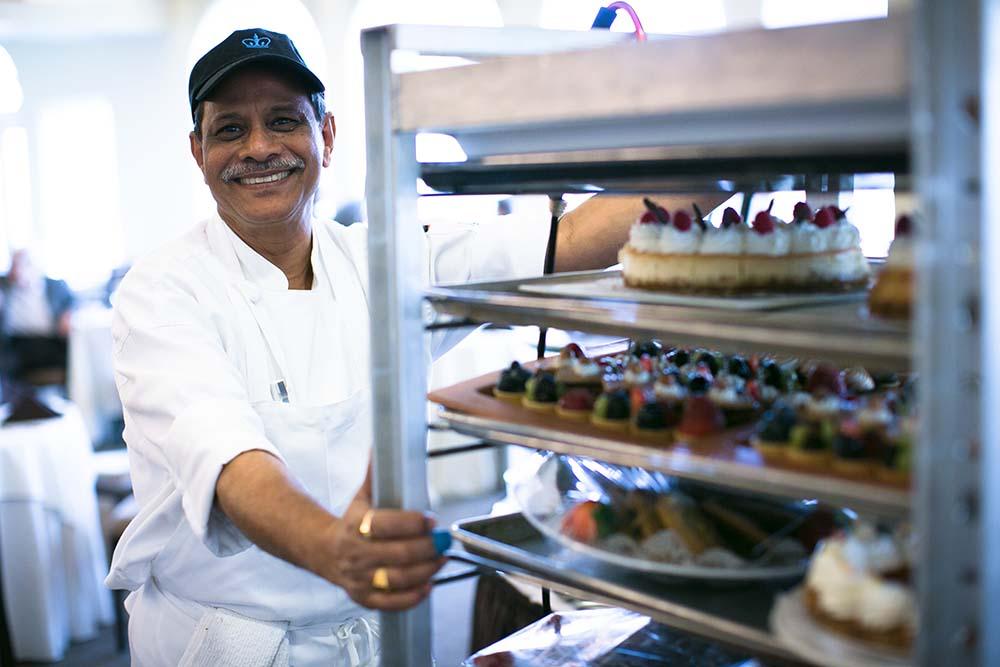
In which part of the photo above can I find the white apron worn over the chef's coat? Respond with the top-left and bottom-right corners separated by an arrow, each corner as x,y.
127,227 -> 378,667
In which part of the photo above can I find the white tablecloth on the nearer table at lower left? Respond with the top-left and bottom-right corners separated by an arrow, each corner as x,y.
0,404 -> 112,661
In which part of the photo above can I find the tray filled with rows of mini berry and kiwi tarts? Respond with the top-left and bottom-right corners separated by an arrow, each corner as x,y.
430,340 -> 917,490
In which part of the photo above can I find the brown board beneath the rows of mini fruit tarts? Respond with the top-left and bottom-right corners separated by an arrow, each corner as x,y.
428,362 -> 909,491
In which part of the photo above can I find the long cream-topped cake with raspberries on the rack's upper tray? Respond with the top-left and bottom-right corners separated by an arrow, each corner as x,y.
618,199 -> 870,294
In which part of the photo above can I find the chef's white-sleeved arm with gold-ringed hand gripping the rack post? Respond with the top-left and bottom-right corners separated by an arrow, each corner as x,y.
112,264 -> 441,609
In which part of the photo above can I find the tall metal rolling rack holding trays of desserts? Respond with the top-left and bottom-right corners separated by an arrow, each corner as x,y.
362,1 -> 1000,666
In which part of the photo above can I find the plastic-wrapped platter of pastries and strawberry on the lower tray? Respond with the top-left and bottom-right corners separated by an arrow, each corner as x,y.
508,454 -> 851,583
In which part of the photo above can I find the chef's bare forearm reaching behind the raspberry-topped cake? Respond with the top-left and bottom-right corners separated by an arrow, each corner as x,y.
555,194 -> 729,271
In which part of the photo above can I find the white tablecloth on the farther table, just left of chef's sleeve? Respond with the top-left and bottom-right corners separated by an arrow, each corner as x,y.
67,305 -> 122,442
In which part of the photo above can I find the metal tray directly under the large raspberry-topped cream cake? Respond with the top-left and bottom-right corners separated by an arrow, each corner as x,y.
426,272 -> 911,372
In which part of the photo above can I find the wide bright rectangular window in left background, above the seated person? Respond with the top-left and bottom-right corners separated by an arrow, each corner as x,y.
38,97 -> 124,289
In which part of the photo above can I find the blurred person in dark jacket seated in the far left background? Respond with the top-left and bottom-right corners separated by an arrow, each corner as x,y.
0,249 -> 76,384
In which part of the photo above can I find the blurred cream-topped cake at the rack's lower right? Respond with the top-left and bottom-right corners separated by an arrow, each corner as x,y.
805,524 -> 917,650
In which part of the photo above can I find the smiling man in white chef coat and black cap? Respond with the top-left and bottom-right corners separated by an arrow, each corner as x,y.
108,29 -> 688,667
